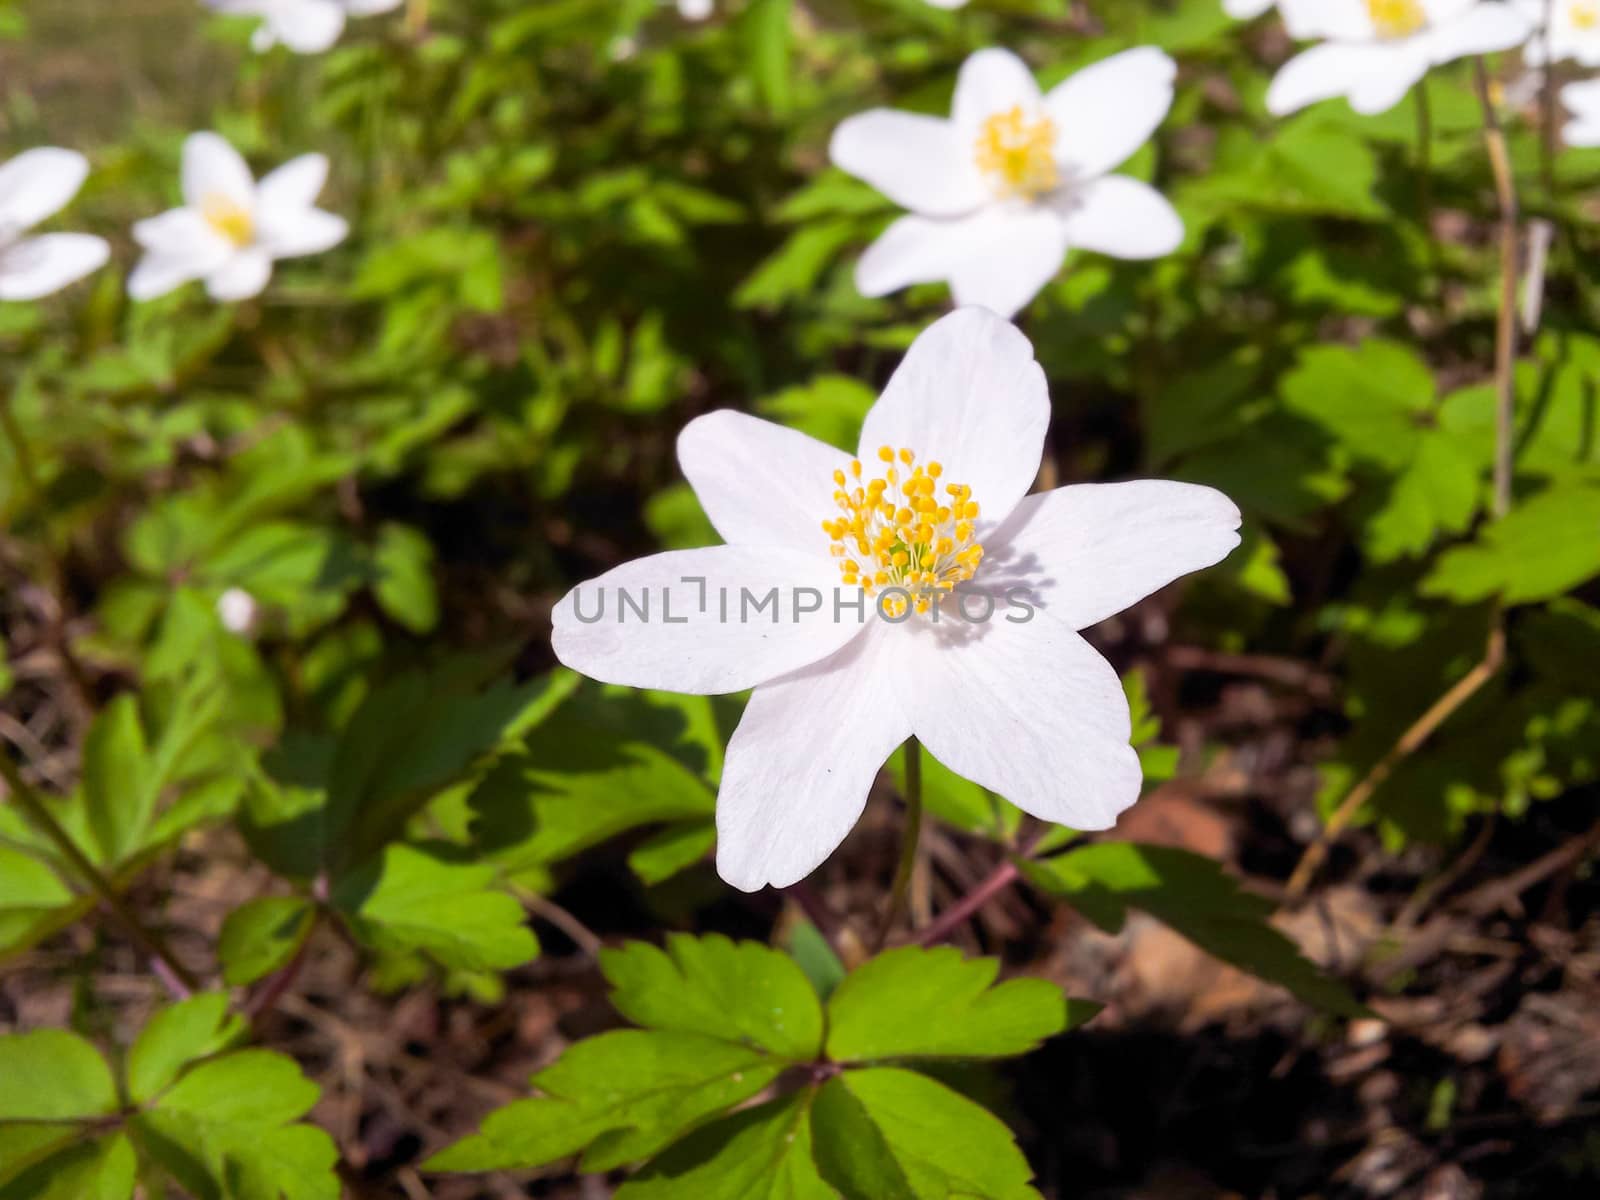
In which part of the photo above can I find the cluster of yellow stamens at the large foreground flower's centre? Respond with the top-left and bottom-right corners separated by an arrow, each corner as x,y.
822,446 -> 984,618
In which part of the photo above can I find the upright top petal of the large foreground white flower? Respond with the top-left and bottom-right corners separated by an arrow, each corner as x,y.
861,309 -> 1050,523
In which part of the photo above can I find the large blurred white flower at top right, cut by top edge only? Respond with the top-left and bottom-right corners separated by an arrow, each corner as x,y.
1267,0 -> 1533,117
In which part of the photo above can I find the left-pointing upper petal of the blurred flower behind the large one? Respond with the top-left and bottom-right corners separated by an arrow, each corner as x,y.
827,109 -> 987,216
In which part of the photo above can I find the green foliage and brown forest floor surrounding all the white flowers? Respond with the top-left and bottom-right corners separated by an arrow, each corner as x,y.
0,0 -> 1600,1200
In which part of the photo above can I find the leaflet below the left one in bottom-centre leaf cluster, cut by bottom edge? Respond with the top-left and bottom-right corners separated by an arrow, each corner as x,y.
616,1091 -> 838,1200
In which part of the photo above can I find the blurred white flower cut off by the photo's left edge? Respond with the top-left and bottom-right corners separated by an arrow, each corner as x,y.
0,146 -> 110,301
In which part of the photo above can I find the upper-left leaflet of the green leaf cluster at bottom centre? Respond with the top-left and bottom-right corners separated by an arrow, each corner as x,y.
600,934 -> 822,1062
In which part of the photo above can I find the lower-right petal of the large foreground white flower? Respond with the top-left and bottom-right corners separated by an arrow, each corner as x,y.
898,610 -> 1142,829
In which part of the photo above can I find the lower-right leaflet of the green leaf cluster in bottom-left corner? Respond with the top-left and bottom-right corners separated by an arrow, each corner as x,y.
133,1050 -> 339,1200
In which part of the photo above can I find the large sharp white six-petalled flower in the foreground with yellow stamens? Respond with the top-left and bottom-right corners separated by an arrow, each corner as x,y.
552,309 -> 1240,891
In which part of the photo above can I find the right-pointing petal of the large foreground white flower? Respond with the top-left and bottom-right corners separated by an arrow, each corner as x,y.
979,480 -> 1240,629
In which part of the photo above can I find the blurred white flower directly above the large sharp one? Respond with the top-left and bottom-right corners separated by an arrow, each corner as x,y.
829,46 -> 1184,317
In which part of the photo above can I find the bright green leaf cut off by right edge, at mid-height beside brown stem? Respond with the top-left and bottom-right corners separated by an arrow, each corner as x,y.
1422,485 -> 1600,605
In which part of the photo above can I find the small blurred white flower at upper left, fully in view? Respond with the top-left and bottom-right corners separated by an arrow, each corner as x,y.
128,133 -> 349,301
